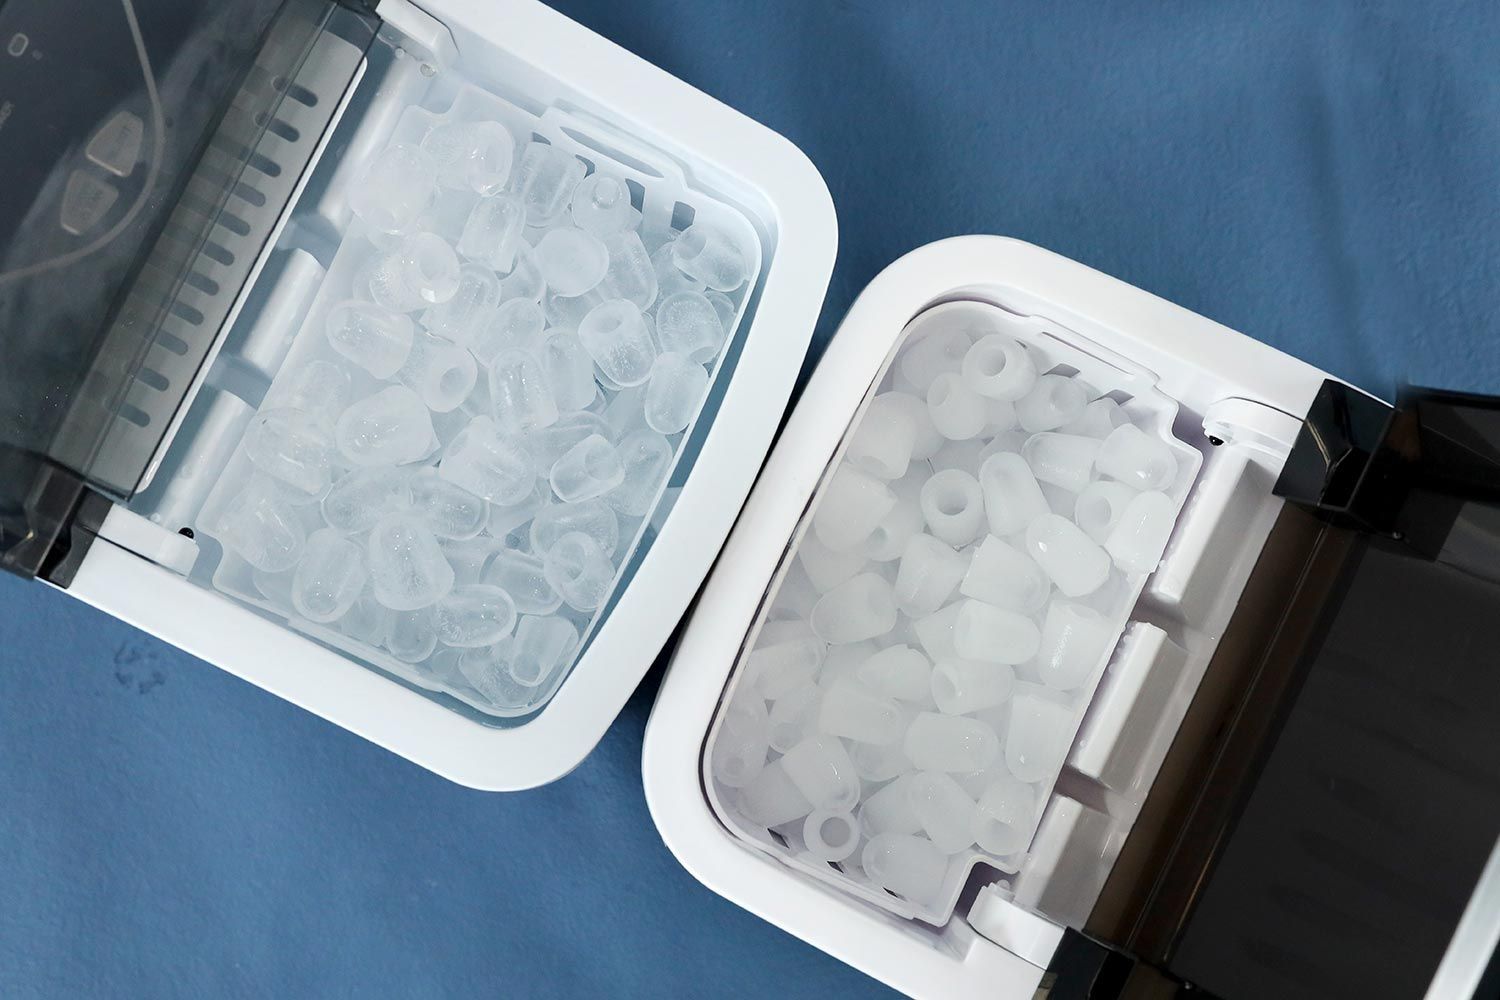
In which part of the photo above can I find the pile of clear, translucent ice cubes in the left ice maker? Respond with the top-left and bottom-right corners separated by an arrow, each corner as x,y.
204,120 -> 752,711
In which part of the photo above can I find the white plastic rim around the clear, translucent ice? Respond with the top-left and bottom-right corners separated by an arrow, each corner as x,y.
68,0 -> 837,790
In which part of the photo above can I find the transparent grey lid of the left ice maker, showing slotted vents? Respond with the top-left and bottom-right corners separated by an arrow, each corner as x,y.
0,0 -> 378,573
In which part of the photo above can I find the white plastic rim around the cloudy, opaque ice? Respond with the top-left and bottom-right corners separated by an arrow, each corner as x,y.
642,235 -> 1325,1000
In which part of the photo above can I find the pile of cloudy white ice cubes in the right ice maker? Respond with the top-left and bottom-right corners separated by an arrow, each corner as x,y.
710,322 -> 1179,913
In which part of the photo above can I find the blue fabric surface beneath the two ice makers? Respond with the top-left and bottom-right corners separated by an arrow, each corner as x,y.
0,0 -> 1500,997
